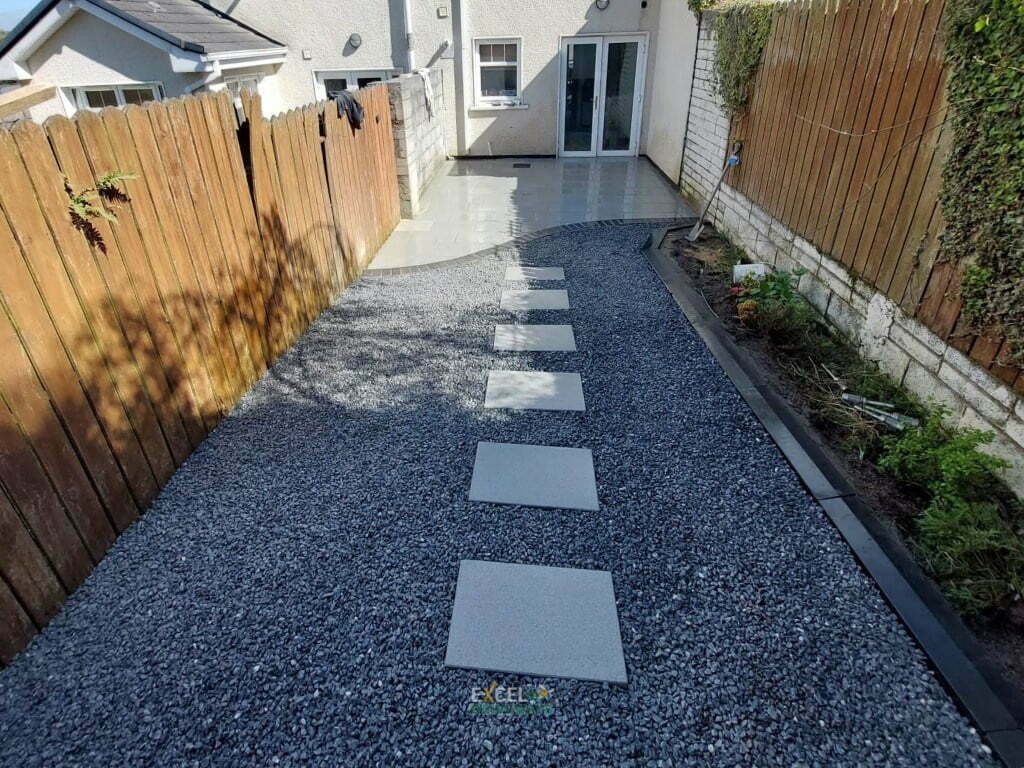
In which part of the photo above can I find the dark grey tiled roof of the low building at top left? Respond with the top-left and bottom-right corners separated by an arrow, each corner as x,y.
0,0 -> 285,55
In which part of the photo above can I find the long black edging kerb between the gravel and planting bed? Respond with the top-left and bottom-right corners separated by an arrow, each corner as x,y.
645,228 -> 1024,768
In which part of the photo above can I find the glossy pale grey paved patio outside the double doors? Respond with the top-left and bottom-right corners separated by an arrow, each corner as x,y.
370,158 -> 695,271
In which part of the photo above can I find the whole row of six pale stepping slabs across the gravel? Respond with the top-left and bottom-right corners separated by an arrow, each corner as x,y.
444,265 -> 627,684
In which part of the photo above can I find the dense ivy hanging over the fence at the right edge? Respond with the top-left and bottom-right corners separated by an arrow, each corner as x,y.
941,0 -> 1024,364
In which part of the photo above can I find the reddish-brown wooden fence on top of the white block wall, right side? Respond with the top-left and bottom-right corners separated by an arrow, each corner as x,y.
730,0 -> 1024,390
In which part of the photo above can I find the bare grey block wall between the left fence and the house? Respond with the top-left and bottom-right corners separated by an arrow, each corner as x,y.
387,69 -> 445,218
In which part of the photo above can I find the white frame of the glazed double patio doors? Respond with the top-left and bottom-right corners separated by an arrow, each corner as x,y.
555,32 -> 650,158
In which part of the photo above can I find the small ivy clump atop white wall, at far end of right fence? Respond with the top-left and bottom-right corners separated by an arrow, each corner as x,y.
714,2 -> 775,118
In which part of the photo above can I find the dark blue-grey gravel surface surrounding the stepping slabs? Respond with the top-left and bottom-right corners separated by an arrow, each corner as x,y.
0,225 -> 990,768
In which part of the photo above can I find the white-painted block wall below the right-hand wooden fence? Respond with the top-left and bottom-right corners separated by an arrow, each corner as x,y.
680,13 -> 1024,496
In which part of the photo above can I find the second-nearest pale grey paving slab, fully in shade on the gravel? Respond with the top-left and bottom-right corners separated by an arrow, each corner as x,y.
469,442 -> 600,511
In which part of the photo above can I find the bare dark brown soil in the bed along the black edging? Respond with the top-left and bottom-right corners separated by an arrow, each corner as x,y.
664,228 -> 1024,700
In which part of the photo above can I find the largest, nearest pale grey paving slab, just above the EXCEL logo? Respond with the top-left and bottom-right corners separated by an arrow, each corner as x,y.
444,560 -> 627,685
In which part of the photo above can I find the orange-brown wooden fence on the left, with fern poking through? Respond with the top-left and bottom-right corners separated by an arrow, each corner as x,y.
0,87 -> 398,660
